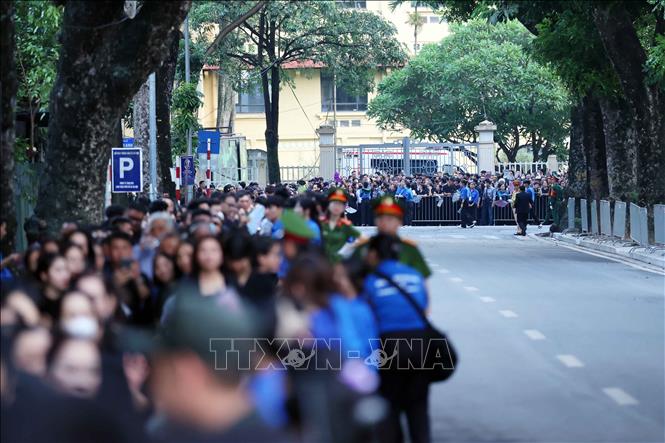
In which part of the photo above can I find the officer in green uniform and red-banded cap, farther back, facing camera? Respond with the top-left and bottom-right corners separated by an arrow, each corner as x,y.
321,189 -> 361,263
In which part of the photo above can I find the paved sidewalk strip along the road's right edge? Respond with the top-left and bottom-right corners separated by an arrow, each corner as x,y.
552,233 -> 665,271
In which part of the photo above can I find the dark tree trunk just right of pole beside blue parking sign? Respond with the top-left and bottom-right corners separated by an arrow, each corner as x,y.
156,35 -> 180,198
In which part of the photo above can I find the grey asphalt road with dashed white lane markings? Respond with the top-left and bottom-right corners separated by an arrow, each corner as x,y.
364,227 -> 665,442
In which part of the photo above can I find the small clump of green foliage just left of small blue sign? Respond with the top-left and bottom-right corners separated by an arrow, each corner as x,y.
171,82 -> 202,155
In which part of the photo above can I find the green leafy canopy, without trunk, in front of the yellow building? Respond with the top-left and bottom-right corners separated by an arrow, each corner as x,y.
184,1 -> 406,96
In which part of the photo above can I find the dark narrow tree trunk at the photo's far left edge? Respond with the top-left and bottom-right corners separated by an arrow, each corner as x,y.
0,1 -> 18,254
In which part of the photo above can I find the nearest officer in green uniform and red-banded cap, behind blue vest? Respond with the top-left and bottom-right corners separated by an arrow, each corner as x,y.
354,195 -> 432,278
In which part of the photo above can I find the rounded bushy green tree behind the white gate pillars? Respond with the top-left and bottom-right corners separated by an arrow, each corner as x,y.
368,20 -> 569,162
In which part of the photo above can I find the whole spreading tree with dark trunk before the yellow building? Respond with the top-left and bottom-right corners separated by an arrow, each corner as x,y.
192,1 -> 405,183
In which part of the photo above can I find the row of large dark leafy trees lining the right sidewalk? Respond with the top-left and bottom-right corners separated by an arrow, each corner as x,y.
402,0 -> 665,204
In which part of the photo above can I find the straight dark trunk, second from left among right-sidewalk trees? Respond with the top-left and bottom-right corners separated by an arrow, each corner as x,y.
583,94 -> 609,199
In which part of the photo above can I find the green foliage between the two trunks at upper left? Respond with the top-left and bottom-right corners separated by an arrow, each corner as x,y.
15,0 -> 62,109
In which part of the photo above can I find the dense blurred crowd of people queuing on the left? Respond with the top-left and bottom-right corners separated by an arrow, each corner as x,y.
0,181 -> 454,442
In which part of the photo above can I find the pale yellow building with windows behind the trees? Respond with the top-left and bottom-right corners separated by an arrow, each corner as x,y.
199,1 -> 448,166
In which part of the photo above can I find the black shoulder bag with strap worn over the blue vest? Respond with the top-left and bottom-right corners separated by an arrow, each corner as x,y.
375,271 -> 457,382
